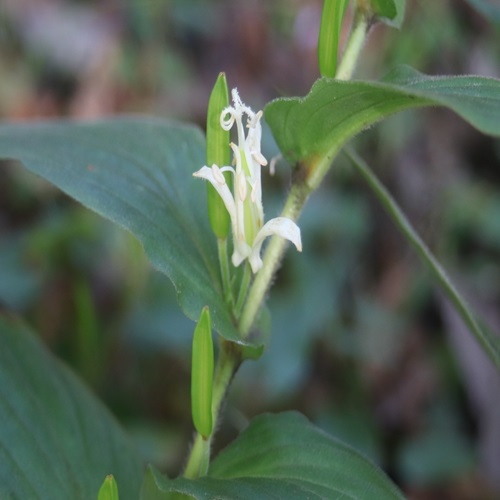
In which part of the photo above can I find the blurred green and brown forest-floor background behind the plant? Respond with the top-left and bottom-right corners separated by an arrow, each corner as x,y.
0,0 -> 500,500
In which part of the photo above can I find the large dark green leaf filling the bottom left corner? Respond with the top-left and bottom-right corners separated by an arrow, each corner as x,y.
0,315 -> 142,500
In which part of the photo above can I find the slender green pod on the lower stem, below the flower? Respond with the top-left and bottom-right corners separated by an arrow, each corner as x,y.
191,307 -> 214,438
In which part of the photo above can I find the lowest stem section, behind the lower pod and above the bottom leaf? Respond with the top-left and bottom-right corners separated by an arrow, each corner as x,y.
184,340 -> 241,479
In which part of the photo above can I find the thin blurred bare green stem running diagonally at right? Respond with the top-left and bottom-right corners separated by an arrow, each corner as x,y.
345,149 -> 500,366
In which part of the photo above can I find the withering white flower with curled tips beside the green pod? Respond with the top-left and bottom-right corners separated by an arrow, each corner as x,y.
193,89 -> 302,273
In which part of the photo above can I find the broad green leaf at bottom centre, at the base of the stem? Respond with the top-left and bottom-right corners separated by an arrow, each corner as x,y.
141,412 -> 403,500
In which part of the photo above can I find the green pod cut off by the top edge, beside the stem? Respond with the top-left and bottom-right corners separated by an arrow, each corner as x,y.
318,0 -> 349,78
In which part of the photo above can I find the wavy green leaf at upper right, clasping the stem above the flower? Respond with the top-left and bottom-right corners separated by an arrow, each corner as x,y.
265,66 -> 500,166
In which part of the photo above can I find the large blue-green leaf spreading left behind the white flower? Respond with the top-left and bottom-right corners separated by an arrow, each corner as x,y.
0,117 -> 243,341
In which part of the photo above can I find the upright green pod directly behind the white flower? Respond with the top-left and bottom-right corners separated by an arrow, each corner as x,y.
207,73 -> 232,240
